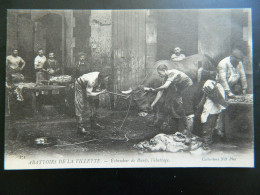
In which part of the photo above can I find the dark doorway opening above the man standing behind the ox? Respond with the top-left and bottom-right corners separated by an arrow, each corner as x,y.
157,10 -> 198,60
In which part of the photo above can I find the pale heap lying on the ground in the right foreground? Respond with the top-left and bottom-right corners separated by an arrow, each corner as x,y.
134,132 -> 202,152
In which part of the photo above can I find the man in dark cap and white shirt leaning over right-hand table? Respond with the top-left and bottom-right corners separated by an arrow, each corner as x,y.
217,49 -> 247,97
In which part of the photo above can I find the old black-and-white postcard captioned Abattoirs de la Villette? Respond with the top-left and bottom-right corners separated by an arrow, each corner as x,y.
4,9 -> 254,170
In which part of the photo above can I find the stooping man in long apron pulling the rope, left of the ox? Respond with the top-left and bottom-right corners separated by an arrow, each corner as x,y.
74,69 -> 110,134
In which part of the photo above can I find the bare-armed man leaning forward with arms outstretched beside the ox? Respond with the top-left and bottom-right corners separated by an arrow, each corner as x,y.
144,64 -> 194,144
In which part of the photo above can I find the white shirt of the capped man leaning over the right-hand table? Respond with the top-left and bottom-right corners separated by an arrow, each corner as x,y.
217,56 -> 247,91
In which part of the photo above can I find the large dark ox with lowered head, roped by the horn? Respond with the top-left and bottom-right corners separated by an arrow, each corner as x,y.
122,54 -> 217,112
